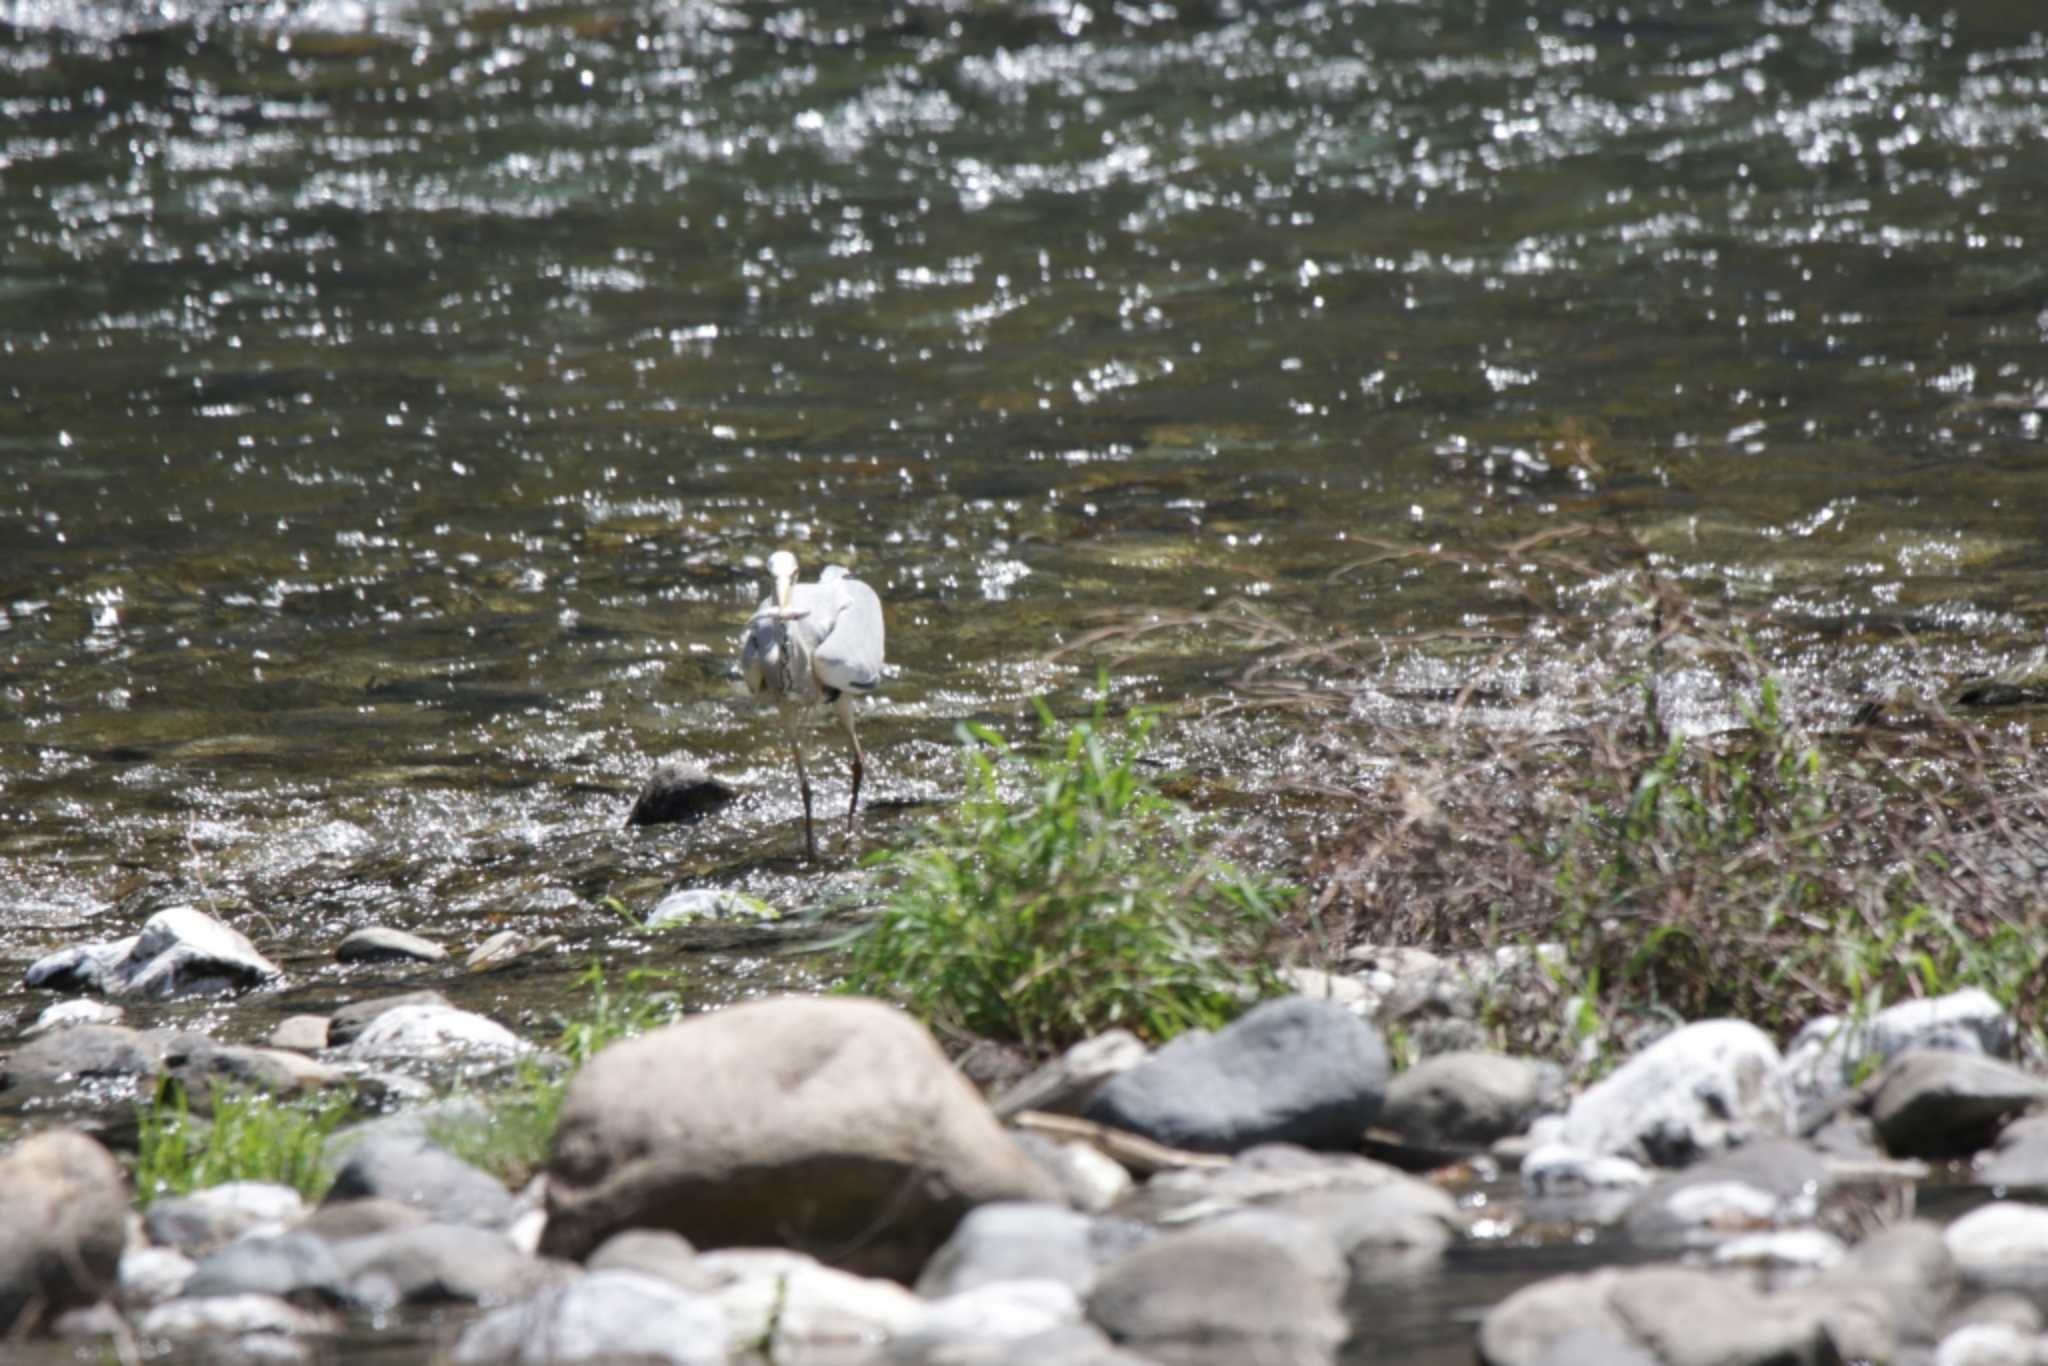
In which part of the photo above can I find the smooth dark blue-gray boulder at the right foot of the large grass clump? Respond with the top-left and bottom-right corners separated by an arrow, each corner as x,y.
1083,995 -> 1386,1153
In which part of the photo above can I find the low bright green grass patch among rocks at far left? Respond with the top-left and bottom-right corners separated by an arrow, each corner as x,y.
135,1077 -> 354,1206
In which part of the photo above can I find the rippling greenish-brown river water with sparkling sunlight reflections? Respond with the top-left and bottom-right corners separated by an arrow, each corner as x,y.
0,0 -> 2048,1359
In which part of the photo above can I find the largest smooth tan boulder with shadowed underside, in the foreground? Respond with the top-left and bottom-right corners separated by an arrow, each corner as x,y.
543,997 -> 1061,1280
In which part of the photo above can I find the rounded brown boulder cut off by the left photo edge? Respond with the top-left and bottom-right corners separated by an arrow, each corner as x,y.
0,1130 -> 127,1341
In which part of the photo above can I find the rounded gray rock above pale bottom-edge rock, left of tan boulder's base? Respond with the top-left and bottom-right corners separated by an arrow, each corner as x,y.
334,1223 -> 565,1311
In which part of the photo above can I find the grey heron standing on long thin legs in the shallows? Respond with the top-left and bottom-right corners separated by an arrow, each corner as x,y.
739,551 -> 883,858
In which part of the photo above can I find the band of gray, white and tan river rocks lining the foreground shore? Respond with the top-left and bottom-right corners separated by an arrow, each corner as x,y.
0,909 -> 2048,1366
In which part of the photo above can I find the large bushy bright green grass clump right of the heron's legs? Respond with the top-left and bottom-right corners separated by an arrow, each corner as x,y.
842,702 -> 1292,1049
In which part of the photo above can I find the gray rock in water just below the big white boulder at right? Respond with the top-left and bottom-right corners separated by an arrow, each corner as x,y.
1626,1139 -> 1831,1249
